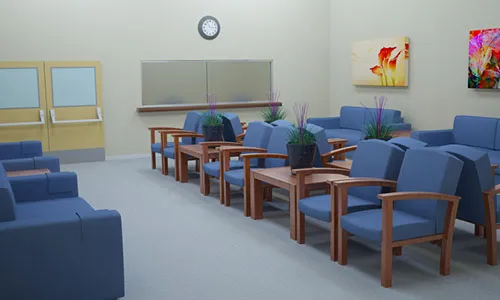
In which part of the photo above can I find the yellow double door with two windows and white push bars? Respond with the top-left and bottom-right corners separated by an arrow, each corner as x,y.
0,62 -> 104,161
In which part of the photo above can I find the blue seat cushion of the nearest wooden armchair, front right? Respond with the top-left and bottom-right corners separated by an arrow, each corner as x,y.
340,209 -> 437,241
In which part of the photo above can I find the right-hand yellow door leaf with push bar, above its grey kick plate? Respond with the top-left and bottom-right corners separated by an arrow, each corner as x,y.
45,62 -> 104,151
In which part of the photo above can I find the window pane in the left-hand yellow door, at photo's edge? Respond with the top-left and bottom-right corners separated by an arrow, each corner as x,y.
0,68 -> 40,109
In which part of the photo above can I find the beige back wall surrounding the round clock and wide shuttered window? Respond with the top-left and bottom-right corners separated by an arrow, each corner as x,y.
0,0 -> 330,155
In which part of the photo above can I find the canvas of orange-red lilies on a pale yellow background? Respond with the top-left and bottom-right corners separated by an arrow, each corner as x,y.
351,37 -> 410,87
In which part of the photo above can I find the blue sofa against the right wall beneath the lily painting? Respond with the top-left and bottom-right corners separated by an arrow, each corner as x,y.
307,106 -> 411,146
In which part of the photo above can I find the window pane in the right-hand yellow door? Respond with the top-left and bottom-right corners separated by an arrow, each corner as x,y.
51,67 -> 97,107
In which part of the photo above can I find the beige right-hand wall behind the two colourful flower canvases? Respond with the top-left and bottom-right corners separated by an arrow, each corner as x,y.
330,0 -> 500,129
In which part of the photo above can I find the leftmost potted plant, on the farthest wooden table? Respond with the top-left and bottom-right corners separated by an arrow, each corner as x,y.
202,94 -> 224,142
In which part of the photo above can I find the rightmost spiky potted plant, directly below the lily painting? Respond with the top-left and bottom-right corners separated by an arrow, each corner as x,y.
364,96 -> 393,141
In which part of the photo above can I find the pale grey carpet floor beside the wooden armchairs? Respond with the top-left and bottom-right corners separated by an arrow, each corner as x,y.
64,159 -> 500,300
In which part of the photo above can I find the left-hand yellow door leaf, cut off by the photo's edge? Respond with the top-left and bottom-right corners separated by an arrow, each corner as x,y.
0,62 -> 49,151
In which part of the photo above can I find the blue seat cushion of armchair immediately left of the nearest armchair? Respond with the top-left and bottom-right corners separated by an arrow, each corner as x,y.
299,195 -> 380,222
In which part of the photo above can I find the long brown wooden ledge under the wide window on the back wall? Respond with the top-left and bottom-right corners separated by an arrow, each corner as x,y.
137,101 -> 283,113
